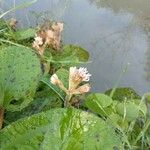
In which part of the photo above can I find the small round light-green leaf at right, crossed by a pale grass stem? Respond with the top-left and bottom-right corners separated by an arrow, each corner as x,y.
116,101 -> 139,121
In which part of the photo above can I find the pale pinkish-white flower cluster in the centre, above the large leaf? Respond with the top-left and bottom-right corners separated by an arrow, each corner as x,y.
50,67 -> 91,106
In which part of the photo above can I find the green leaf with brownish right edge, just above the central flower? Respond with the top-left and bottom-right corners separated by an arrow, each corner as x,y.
53,45 -> 89,66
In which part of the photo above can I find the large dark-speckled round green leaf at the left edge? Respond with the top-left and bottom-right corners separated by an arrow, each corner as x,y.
0,46 -> 41,111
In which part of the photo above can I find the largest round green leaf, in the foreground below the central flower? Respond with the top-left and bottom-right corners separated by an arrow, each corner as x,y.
0,108 -> 123,150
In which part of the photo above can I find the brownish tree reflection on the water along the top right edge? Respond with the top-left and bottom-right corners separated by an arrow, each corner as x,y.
88,0 -> 150,80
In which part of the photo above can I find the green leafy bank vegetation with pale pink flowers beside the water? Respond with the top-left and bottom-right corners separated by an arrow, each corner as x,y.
0,15 -> 150,150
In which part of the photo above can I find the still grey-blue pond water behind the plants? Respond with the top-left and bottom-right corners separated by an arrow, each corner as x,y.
0,0 -> 150,94
